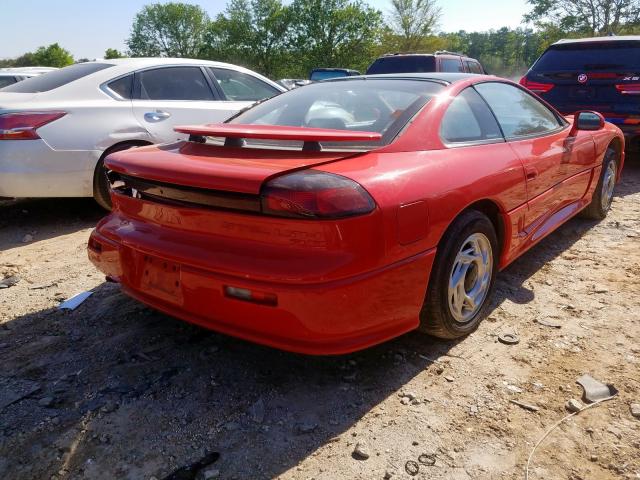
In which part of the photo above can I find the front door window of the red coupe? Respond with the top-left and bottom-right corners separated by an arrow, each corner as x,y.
475,82 -> 561,138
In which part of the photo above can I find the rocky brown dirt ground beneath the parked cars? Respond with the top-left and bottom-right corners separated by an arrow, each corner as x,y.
0,161 -> 640,480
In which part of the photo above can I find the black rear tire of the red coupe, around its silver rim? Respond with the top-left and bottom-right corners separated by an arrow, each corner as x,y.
419,210 -> 500,339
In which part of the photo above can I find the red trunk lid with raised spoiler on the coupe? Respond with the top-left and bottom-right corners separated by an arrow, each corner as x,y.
105,124 -> 379,195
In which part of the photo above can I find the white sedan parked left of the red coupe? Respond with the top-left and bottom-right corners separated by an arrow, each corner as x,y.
0,58 -> 285,208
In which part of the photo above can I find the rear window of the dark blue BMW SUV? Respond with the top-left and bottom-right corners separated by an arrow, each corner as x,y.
532,42 -> 640,73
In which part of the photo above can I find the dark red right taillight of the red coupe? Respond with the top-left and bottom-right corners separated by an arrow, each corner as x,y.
262,170 -> 376,219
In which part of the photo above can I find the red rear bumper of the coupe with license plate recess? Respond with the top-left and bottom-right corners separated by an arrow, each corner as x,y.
89,228 -> 435,355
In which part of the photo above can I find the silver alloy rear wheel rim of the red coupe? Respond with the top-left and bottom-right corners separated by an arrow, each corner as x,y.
449,233 -> 493,323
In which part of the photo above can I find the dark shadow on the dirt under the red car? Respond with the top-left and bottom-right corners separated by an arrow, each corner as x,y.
0,283 -> 456,479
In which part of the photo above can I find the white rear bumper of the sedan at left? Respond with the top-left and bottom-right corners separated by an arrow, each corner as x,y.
0,140 -> 101,197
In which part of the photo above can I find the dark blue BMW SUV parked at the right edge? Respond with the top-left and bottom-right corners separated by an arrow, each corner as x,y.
520,36 -> 640,151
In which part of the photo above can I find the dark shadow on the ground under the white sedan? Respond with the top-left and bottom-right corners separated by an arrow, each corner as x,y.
0,198 -> 106,251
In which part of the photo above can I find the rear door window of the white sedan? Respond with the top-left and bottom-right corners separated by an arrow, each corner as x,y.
136,67 -> 214,100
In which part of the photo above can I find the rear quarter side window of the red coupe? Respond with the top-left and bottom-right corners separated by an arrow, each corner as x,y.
440,87 -> 503,143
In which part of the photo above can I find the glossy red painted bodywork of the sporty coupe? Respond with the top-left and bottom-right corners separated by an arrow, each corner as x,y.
89,76 -> 624,354
